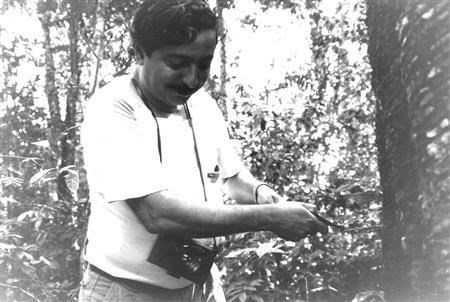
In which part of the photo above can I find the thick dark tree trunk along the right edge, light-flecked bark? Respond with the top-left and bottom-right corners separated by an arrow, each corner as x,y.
367,0 -> 450,301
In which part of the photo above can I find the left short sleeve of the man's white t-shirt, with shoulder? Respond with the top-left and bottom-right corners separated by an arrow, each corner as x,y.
81,96 -> 167,202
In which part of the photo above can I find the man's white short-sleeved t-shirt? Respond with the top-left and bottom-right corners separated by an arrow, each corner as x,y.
81,75 -> 242,289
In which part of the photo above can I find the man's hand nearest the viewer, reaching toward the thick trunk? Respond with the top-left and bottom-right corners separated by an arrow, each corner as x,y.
271,202 -> 328,241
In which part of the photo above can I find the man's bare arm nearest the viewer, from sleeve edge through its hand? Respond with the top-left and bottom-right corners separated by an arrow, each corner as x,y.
128,191 -> 328,241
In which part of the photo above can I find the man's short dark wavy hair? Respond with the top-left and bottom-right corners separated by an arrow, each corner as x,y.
131,0 -> 218,56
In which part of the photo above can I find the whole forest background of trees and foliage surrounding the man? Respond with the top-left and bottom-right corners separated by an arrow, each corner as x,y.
0,0 -> 450,301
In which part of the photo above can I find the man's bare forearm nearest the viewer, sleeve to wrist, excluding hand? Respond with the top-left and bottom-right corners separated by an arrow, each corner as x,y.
128,191 -> 276,238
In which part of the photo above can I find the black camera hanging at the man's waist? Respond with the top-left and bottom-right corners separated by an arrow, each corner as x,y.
147,234 -> 217,285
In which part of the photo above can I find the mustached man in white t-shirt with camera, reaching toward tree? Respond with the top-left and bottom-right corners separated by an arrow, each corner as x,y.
79,0 -> 327,301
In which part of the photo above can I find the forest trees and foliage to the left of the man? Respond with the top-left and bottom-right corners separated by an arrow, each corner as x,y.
0,0 -> 144,301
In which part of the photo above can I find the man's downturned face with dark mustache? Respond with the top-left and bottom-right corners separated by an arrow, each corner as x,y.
137,30 -> 216,109
